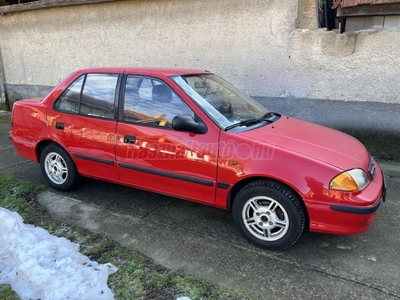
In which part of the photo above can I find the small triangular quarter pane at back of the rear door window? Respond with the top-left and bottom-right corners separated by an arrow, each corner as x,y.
54,76 -> 85,113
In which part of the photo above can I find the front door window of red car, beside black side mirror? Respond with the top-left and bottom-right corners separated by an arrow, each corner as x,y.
123,75 -> 194,128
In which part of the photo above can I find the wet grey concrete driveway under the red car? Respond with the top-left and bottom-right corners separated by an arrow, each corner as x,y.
0,123 -> 400,299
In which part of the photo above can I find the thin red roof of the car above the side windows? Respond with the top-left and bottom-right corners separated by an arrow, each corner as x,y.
77,67 -> 210,76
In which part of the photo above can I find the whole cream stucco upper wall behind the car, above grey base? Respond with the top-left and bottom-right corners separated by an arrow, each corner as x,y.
0,0 -> 400,103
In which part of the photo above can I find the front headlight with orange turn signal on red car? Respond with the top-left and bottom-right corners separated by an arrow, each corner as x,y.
329,169 -> 369,192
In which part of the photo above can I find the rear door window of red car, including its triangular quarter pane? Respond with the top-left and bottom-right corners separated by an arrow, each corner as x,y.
54,74 -> 119,119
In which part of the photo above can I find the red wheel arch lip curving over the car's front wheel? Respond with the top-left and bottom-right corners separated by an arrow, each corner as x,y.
227,176 -> 310,231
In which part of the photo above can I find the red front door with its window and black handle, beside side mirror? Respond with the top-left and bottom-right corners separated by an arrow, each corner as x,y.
116,75 -> 218,202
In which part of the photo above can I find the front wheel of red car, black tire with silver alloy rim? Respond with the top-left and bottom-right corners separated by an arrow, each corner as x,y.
232,180 -> 306,250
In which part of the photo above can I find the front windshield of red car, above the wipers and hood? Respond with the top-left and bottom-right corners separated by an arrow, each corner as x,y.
172,74 -> 268,128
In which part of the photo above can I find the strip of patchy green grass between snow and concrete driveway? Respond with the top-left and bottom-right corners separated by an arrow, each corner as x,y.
0,174 -> 255,300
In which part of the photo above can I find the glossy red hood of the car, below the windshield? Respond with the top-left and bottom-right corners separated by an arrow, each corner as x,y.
240,115 -> 369,170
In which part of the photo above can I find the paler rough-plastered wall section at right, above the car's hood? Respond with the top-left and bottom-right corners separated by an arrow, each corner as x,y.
288,29 -> 400,103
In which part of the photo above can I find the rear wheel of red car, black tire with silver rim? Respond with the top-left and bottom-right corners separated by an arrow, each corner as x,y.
40,145 -> 80,191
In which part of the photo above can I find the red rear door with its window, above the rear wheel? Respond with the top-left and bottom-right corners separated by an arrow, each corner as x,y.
48,74 -> 121,180
